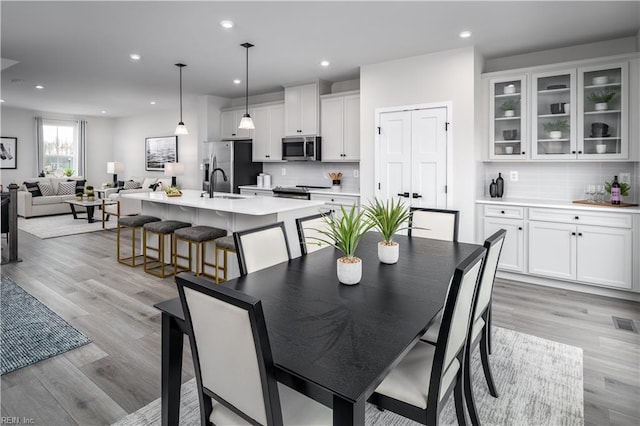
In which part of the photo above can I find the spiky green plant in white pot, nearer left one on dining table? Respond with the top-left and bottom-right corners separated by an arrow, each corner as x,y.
309,206 -> 373,285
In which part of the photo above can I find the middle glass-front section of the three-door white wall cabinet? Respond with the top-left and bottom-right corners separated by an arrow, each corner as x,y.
531,70 -> 577,159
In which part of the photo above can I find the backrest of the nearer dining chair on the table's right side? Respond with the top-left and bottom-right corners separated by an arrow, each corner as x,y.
429,248 -> 486,395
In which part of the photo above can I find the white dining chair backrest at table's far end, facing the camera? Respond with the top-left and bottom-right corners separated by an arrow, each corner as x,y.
409,207 -> 460,241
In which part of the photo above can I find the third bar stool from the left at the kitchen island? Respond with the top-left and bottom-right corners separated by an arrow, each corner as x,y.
173,225 -> 227,279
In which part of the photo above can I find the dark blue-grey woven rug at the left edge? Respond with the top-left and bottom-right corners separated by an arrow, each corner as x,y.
0,277 -> 91,375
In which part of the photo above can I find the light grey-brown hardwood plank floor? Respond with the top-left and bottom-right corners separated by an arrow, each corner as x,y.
0,231 -> 640,425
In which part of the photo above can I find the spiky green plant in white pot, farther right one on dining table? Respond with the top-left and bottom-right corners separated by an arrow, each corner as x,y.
364,198 -> 411,264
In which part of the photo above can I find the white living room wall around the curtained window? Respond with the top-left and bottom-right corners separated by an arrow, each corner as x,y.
1,106 -> 113,186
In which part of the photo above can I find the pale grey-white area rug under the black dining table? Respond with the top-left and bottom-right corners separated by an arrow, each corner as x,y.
114,327 -> 584,426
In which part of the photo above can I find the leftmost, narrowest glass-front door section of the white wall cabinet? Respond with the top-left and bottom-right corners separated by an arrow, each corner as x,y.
489,76 -> 527,161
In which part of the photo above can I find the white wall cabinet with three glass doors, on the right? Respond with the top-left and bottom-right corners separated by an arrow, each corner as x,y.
488,55 -> 640,161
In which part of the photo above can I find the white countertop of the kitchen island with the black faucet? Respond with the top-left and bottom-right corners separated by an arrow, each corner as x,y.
122,189 -> 324,216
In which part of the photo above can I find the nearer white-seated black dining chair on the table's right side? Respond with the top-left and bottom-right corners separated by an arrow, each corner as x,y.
369,248 -> 485,425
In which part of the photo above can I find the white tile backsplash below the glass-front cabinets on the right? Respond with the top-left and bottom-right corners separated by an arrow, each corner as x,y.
479,162 -> 640,202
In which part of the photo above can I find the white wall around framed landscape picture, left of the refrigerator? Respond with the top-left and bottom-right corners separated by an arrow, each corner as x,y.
111,96 -> 201,189
